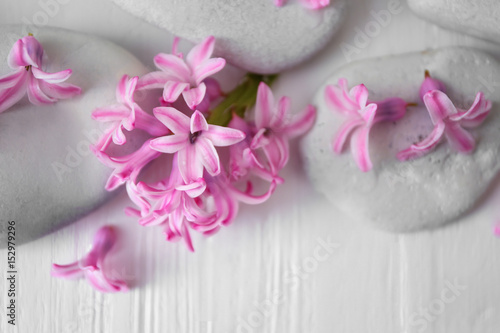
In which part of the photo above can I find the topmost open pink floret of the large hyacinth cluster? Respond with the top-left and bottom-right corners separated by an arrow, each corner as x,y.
138,36 -> 226,110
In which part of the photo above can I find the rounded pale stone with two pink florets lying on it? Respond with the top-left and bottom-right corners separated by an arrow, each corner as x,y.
301,48 -> 500,232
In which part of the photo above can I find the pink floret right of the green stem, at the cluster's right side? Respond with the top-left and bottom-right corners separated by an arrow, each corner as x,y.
250,82 -> 316,175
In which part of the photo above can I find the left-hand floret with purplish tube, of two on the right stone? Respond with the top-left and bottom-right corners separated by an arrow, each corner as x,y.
325,78 -> 407,172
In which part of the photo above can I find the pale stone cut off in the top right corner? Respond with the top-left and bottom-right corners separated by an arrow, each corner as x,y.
408,0 -> 500,43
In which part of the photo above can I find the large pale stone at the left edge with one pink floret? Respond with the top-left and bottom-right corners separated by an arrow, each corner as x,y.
0,26 -> 147,247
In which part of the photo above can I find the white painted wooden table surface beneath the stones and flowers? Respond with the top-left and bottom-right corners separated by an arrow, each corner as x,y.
0,0 -> 500,333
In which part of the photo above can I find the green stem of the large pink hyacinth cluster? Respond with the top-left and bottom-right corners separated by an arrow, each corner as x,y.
207,73 -> 278,126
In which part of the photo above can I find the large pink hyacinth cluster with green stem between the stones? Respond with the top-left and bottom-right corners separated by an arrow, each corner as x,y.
87,37 -> 316,251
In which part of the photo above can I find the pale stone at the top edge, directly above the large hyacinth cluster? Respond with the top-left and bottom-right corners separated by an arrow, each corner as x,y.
107,0 -> 345,74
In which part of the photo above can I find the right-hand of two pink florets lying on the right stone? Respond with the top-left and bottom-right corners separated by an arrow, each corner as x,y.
397,90 -> 491,161
